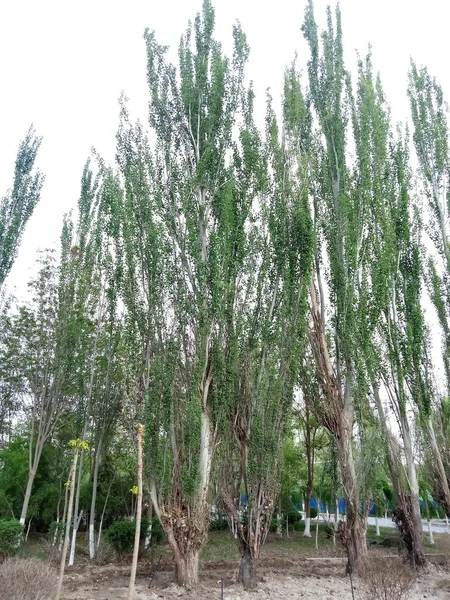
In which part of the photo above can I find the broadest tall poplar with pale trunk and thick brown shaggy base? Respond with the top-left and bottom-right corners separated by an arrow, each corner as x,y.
116,0 -> 255,586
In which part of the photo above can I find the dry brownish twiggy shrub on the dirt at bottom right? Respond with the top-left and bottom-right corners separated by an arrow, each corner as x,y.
359,557 -> 416,600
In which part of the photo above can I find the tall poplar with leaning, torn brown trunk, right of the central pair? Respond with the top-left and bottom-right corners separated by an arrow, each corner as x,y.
303,0 -> 367,570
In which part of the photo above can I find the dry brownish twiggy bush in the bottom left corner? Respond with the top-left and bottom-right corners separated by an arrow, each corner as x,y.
0,557 -> 57,600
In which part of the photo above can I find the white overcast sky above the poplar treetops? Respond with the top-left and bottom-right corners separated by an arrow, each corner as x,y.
0,0 -> 450,294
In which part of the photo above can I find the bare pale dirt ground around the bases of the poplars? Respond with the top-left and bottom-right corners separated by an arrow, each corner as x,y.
63,556 -> 450,600
